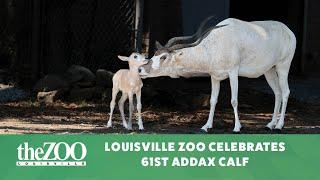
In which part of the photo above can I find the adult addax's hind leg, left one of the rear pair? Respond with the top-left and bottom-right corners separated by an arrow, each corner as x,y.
264,68 -> 281,129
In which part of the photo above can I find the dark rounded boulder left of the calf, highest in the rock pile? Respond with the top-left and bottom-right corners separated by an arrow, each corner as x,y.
64,65 -> 96,87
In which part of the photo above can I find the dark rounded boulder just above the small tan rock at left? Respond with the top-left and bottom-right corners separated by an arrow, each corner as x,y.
33,74 -> 70,92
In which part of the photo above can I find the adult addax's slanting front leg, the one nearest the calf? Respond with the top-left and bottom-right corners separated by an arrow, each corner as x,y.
201,77 -> 220,132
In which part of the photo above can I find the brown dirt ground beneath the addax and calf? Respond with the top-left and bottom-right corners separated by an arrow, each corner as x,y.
0,79 -> 320,134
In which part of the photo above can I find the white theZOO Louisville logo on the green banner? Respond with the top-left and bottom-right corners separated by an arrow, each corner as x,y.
16,142 -> 87,166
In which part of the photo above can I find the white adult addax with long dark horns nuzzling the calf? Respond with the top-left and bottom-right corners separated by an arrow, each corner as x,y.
142,18 -> 296,132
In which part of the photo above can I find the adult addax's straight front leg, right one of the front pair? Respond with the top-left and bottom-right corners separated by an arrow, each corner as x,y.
229,69 -> 241,133
